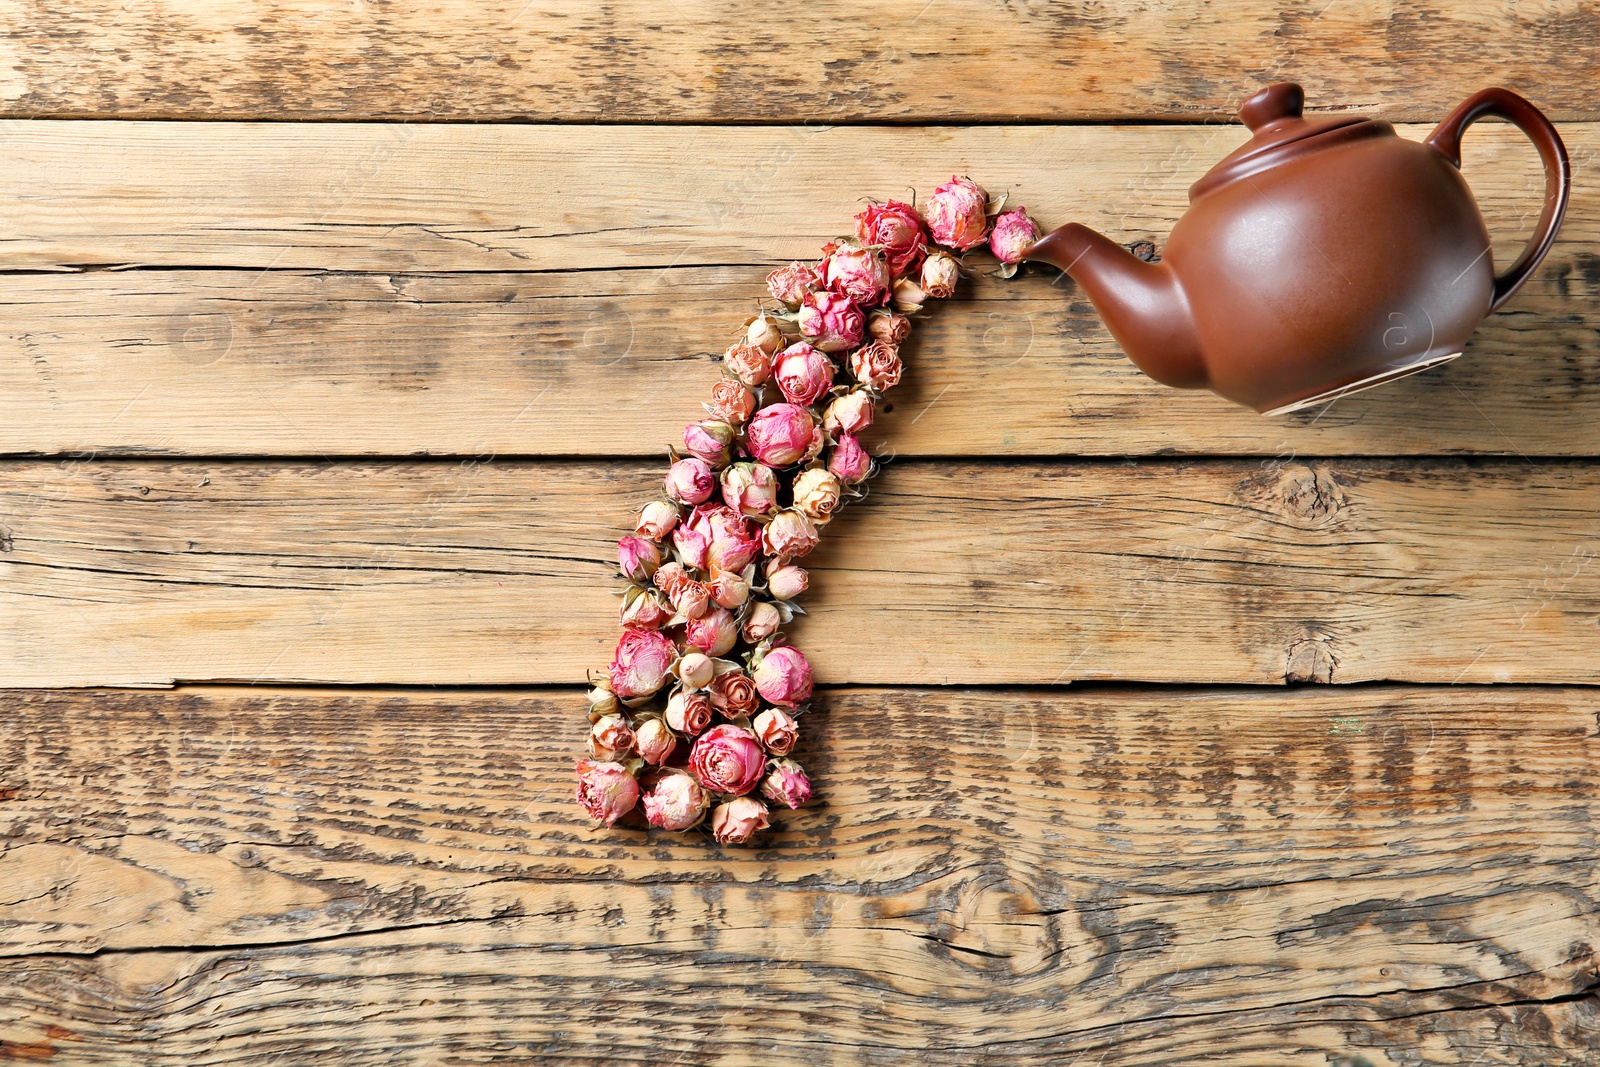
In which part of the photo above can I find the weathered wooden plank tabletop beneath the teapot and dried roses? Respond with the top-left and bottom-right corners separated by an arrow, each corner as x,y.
0,0 -> 1600,1067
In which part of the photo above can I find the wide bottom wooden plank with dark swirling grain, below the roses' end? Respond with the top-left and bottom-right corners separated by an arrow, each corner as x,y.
0,686 -> 1600,1067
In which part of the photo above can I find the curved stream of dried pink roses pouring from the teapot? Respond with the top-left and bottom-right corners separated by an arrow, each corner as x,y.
578,178 -> 1040,843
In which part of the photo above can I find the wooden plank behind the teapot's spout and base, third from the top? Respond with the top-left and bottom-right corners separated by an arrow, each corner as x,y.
0,255 -> 1600,456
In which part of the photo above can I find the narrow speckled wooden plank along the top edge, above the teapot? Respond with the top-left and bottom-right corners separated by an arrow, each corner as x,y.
0,0 -> 1600,123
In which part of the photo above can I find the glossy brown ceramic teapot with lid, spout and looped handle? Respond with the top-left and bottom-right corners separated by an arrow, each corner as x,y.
1024,83 -> 1571,414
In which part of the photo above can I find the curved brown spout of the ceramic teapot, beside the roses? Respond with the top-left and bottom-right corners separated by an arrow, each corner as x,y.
1022,222 -> 1206,389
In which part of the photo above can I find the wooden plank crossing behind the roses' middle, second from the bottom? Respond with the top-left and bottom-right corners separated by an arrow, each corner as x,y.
0,459 -> 1600,686
